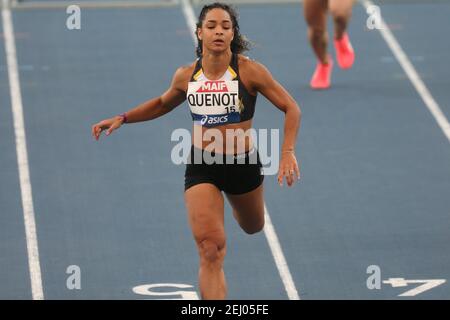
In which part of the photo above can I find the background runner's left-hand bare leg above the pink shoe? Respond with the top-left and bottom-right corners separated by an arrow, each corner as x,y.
303,0 -> 328,64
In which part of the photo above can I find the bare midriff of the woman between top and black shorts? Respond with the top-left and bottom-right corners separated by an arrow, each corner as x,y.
192,119 -> 253,154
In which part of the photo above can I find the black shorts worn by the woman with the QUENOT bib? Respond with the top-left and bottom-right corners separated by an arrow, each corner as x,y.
184,146 -> 264,194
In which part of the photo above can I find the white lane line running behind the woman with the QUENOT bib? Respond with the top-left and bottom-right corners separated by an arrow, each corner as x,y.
180,0 -> 300,300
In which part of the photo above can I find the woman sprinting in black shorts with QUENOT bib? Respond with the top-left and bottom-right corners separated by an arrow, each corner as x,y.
92,3 -> 301,299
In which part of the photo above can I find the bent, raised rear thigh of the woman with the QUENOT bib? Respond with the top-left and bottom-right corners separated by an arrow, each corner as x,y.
226,184 -> 264,234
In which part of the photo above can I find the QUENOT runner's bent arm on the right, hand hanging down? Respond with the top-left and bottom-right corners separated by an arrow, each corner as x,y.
244,61 -> 302,186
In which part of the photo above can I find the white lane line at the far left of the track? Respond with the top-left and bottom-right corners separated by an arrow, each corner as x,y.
2,0 -> 44,300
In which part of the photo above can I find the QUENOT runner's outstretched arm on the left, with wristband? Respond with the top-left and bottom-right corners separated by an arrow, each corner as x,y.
92,67 -> 190,140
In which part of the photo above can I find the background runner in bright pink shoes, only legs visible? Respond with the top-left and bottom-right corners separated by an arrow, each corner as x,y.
303,0 -> 355,89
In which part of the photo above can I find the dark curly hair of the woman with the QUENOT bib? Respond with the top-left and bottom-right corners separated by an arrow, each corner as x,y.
195,2 -> 251,57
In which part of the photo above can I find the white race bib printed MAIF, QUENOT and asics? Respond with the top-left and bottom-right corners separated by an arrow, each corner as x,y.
187,80 -> 241,127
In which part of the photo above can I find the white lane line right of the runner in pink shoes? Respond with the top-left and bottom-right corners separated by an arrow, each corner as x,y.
360,0 -> 450,142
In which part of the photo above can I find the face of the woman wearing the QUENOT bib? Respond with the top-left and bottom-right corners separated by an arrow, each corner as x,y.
197,8 -> 234,53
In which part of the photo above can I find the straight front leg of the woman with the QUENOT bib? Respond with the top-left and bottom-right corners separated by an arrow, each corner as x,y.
184,183 -> 227,299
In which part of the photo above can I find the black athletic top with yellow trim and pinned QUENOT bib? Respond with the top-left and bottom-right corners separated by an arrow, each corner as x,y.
186,53 -> 256,127
